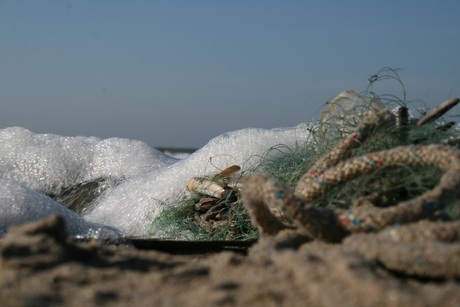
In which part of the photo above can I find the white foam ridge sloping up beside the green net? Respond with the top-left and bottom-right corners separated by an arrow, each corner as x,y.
86,125 -> 309,235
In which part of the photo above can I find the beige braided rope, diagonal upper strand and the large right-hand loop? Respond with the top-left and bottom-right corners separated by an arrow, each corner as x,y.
294,110 -> 460,232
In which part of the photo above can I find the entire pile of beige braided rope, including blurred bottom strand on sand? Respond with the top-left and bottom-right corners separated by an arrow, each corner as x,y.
242,98 -> 460,278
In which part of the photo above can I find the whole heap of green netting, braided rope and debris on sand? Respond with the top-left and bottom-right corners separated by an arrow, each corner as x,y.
147,76 -> 460,280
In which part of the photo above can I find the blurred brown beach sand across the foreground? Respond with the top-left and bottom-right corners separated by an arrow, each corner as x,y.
0,216 -> 460,307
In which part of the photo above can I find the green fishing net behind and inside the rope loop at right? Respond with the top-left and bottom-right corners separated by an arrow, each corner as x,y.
258,91 -> 460,216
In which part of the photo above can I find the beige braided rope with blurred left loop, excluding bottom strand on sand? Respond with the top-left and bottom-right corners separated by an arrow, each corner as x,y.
242,110 -> 460,242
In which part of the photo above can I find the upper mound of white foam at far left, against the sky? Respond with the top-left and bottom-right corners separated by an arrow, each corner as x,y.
0,127 -> 177,193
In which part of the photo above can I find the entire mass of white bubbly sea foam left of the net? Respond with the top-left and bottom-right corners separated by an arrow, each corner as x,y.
0,125 -> 309,236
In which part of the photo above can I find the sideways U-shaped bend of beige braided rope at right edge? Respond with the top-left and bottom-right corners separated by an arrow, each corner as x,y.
332,145 -> 460,232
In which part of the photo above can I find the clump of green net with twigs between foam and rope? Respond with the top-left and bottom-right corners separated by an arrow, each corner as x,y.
149,165 -> 258,240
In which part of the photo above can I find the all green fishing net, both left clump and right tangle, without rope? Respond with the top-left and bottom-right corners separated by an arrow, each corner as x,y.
148,68 -> 460,240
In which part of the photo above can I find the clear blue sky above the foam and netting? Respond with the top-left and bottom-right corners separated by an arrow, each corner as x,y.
0,0 -> 460,147
